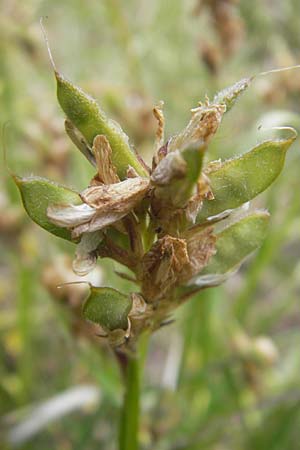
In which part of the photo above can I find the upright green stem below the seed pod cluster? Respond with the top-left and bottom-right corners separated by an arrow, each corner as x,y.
119,355 -> 140,450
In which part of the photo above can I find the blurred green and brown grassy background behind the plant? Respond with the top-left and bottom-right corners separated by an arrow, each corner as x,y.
0,0 -> 300,450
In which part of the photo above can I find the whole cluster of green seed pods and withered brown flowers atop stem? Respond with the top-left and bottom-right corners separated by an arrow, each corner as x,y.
14,54 -> 295,351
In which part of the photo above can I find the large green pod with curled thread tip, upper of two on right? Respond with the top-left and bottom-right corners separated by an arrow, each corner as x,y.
197,136 -> 295,223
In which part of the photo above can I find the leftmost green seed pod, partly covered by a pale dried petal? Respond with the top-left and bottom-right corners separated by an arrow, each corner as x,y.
13,175 -> 82,241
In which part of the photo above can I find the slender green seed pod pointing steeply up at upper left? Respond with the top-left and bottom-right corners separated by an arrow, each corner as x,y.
55,71 -> 148,179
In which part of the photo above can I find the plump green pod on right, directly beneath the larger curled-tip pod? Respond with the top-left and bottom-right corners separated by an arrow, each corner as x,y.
199,211 -> 270,277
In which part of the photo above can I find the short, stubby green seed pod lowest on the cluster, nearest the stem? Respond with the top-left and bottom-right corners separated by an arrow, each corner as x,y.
82,286 -> 132,331
